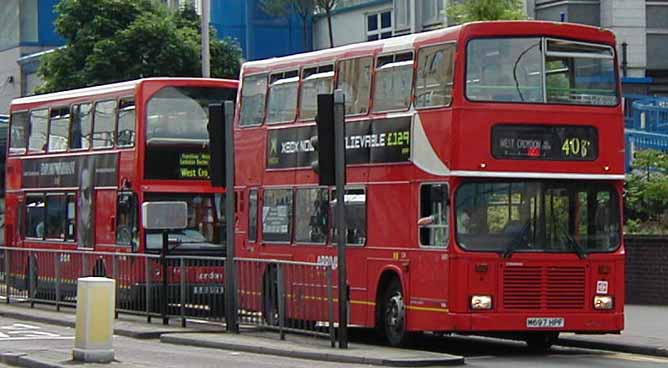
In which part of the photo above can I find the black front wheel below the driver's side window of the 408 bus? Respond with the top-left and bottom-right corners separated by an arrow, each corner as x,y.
380,279 -> 413,346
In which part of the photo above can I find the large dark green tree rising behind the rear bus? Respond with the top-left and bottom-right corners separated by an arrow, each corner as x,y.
37,0 -> 241,93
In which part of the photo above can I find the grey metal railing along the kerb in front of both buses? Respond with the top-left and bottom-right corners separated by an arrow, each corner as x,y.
0,247 -> 337,344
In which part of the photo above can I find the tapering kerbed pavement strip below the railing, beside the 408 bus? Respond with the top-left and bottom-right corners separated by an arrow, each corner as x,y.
160,332 -> 464,367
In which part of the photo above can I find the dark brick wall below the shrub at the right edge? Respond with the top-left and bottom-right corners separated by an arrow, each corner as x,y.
624,236 -> 668,305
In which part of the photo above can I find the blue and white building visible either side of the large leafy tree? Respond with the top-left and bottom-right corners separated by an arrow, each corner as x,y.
0,0 -> 312,114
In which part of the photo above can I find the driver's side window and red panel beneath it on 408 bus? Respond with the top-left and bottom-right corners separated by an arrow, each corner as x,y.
408,183 -> 450,329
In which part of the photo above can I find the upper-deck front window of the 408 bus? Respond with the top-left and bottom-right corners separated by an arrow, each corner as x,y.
466,37 -> 618,106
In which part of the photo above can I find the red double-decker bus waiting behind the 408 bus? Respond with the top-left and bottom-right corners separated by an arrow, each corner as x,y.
5,78 -> 238,310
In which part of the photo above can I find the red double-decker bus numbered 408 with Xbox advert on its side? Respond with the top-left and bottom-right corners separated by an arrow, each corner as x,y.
235,21 -> 624,348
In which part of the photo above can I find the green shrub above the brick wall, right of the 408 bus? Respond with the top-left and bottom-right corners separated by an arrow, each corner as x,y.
626,150 -> 668,233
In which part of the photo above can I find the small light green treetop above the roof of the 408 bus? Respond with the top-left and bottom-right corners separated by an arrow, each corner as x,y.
448,0 -> 527,24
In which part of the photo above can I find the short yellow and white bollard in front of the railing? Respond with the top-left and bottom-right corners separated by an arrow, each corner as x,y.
72,277 -> 116,363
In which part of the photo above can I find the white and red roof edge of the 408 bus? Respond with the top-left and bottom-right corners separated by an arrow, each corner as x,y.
242,20 -> 615,74
